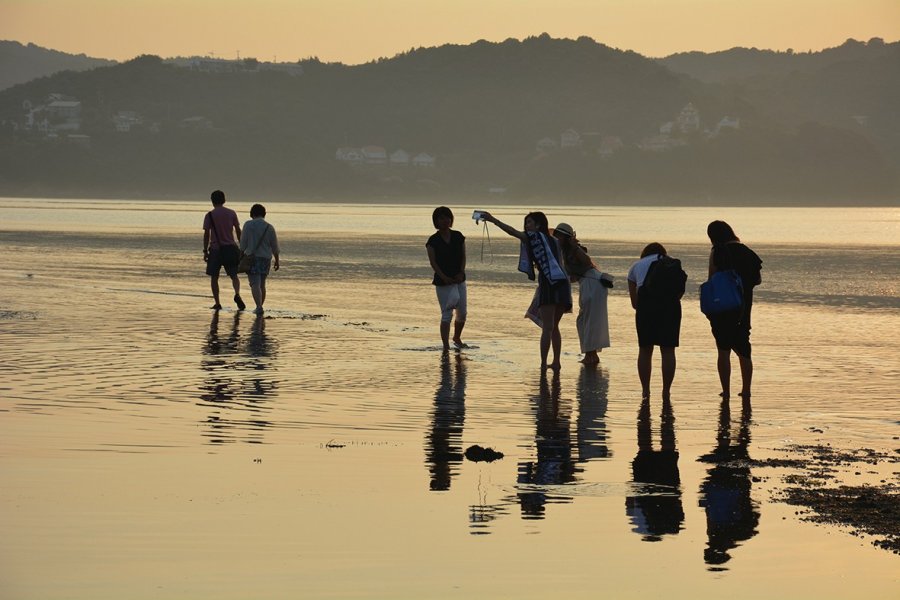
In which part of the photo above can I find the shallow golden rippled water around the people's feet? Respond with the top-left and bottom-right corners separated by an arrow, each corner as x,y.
0,200 -> 900,598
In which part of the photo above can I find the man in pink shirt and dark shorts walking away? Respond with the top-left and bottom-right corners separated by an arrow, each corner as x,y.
203,190 -> 246,310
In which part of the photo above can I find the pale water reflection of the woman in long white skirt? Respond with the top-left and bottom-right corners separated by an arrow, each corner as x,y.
575,365 -> 612,462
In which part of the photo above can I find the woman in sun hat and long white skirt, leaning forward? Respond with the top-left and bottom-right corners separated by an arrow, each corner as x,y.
553,223 -> 612,365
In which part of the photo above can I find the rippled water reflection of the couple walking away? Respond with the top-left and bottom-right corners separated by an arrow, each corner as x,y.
198,311 -> 278,444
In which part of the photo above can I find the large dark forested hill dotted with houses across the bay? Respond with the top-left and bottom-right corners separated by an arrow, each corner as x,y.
0,34 -> 900,203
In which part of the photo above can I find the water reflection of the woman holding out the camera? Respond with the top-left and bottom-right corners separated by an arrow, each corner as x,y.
517,371 -> 575,519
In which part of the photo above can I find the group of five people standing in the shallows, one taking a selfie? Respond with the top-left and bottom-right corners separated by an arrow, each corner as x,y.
426,206 -> 762,401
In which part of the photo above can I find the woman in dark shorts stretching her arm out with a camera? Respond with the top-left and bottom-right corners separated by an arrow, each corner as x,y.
480,211 -> 572,371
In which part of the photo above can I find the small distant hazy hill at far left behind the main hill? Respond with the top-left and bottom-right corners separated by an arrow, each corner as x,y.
0,40 -> 115,90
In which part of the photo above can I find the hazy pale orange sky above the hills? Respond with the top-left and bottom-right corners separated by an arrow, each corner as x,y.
0,0 -> 900,63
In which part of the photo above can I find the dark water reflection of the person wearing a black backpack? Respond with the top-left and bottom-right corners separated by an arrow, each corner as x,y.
625,398 -> 684,542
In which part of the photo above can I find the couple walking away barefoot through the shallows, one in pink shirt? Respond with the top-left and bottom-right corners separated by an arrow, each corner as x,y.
203,190 -> 281,315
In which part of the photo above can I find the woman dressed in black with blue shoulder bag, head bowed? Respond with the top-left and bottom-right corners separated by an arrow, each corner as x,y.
701,221 -> 762,401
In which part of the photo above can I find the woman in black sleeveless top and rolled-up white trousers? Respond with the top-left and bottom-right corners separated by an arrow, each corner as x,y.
425,206 -> 468,352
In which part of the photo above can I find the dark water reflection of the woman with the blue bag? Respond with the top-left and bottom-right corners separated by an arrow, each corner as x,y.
699,400 -> 759,570
